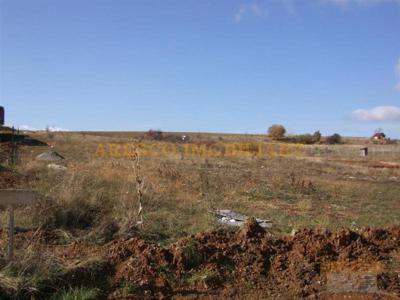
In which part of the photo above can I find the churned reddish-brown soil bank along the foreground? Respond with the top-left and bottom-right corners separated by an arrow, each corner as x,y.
0,220 -> 400,299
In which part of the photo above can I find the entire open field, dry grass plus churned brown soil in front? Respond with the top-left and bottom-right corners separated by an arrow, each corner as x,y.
0,132 -> 400,299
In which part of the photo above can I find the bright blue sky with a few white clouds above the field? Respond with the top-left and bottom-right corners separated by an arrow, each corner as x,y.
0,0 -> 400,138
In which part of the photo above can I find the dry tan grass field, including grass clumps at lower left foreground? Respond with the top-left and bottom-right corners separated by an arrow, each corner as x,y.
0,132 -> 400,299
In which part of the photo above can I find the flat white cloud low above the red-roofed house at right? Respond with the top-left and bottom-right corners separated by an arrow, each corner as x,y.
352,106 -> 400,122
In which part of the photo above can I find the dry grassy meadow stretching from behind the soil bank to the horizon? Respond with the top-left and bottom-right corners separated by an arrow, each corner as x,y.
8,132 -> 400,242
